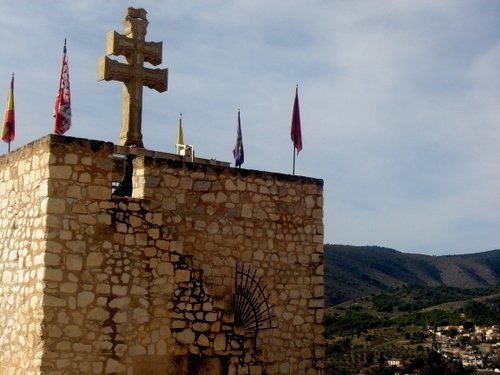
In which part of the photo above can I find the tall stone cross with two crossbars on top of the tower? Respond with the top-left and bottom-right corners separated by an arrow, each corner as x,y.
97,8 -> 168,147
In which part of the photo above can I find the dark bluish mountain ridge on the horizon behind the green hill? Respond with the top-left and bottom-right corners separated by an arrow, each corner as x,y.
324,244 -> 500,307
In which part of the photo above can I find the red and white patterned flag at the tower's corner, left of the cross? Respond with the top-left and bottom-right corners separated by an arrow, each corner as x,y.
54,39 -> 71,134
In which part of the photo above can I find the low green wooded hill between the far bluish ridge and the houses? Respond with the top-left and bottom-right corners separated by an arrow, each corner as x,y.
325,286 -> 500,337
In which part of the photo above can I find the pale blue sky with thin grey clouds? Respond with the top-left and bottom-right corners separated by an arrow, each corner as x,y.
0,0 -> 500,255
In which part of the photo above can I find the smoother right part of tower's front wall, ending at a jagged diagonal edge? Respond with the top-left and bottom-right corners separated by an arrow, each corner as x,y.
134,159 -> 323,374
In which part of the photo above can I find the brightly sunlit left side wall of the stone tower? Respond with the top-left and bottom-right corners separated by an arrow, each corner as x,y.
0,142 -> 50,374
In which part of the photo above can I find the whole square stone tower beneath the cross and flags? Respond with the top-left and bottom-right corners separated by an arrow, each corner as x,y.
0,135 -> 324,375
